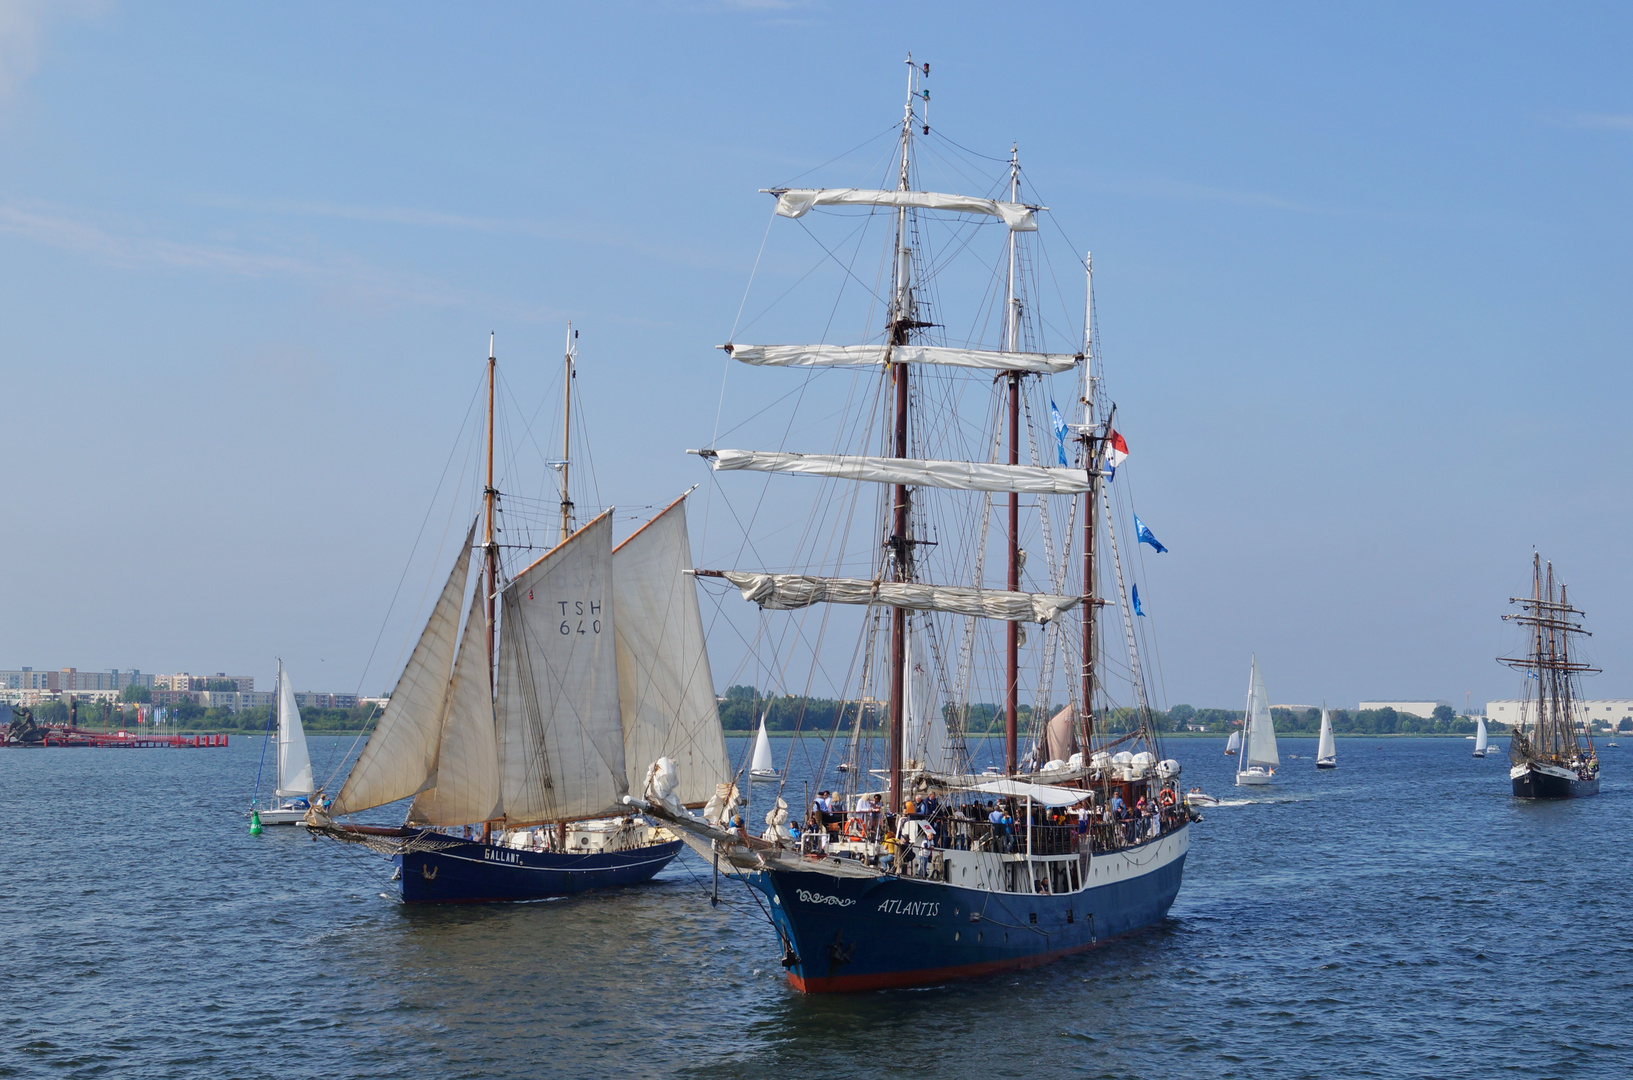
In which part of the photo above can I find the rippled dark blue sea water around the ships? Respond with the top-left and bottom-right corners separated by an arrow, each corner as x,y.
0,728 -> 1633,1080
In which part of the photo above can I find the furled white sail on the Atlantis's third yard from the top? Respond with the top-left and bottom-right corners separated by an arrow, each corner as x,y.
697,449 -> 1089,495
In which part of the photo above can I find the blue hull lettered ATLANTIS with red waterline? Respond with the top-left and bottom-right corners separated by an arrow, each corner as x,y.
748,827 -> 1189,993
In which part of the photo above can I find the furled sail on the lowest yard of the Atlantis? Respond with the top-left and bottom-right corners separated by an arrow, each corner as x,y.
723,570 -> 1083,623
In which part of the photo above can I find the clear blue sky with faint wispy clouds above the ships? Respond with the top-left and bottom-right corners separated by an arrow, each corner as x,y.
0,0 -> 1633,706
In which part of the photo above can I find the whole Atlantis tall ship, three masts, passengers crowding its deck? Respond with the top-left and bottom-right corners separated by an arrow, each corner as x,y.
630,57 -> 1190,992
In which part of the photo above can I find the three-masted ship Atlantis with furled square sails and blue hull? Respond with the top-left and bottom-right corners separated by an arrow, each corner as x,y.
630,57 -> 1189,992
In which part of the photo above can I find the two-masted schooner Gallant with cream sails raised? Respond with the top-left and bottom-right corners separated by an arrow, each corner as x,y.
307,333 -> 728,904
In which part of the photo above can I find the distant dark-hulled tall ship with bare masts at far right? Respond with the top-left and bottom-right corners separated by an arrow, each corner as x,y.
1497,556 -> 1599,799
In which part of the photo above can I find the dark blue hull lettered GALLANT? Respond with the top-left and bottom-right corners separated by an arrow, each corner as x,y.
392,840 -> 681,904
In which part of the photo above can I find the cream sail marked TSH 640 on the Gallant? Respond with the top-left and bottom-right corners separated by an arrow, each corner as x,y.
495,511 -> 629,823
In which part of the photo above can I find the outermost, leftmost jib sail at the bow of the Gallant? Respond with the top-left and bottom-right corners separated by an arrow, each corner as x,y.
330,523 -> 477,815
